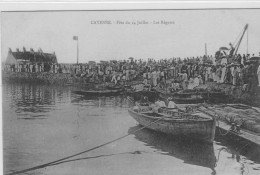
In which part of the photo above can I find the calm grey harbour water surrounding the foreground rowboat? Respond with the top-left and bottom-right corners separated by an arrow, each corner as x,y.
2,83 -> 260,175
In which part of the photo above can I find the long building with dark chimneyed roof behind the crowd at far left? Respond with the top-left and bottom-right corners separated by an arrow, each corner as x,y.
5,48 -> 57,64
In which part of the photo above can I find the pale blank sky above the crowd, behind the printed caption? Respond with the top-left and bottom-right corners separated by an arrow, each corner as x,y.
1,9 -> 260,63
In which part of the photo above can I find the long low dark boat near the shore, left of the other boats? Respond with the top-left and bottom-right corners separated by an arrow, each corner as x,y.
73,89 -> 124,96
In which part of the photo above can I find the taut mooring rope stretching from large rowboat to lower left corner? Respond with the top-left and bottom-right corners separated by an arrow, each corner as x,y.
6,113 -> 164,175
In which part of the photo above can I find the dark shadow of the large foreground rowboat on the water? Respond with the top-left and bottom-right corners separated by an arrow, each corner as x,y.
128,125 -> 217,174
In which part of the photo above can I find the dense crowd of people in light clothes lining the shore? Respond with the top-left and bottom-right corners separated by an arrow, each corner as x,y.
4,54 -> 260,90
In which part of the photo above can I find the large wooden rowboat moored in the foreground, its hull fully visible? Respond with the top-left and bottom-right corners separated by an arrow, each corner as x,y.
128,109 -> 216,143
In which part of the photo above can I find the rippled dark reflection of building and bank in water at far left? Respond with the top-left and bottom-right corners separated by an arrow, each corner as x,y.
3,83 -> 70,119
